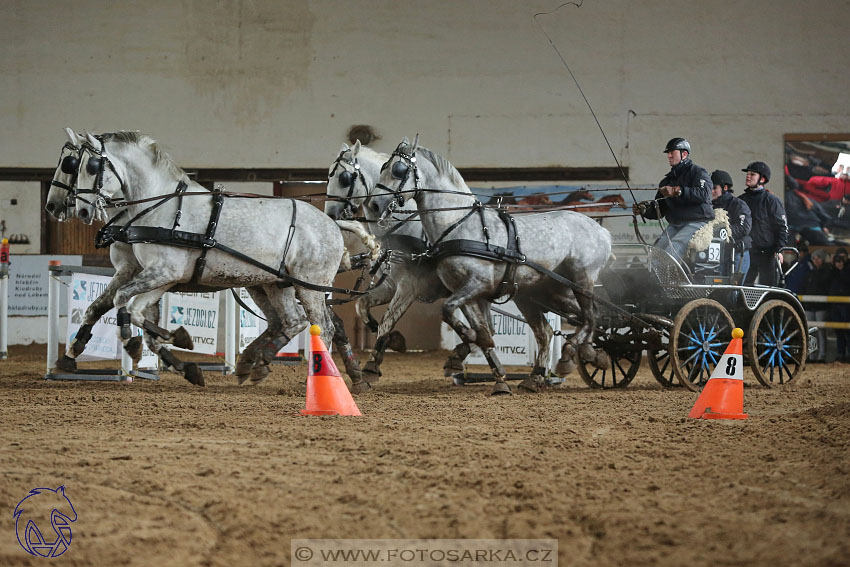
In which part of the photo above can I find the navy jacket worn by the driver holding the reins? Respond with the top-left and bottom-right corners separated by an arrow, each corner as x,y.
644,158 -> 714,224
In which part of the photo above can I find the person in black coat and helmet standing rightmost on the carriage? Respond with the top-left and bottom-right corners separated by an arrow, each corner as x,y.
741,161 -> 788,286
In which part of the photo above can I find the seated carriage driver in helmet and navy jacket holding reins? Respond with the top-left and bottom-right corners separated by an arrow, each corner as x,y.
634,138 -> 714,260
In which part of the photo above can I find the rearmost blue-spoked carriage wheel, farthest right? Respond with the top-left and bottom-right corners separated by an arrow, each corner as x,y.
747,299 -> 808,388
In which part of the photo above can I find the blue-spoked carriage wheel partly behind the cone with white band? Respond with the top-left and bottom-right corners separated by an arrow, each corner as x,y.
670,299 -> 735,392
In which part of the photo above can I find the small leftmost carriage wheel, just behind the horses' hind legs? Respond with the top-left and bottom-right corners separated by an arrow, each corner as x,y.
578,327 -> 642,389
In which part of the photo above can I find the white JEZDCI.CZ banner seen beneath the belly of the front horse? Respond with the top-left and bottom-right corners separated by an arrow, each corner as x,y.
165,291 -> 218,354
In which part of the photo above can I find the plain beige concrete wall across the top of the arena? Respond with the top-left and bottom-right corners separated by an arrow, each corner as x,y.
0,0 -> 850,178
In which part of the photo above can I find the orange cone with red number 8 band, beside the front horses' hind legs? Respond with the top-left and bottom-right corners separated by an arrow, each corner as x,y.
301,325 -> 363,415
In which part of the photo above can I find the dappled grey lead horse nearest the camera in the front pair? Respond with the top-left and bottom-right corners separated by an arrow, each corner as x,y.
71,132 -> 344,385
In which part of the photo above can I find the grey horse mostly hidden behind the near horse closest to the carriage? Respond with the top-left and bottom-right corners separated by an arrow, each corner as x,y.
325,141 -> 450,389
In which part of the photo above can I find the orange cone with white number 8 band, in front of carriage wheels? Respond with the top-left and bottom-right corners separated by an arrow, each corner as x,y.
688,328 -> 747,419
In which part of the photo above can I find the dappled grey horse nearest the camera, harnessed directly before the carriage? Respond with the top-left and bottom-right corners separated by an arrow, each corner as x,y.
369,138 -> 611,394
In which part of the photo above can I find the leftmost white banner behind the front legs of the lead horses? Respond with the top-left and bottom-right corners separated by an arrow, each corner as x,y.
65,273 -> 157,368
